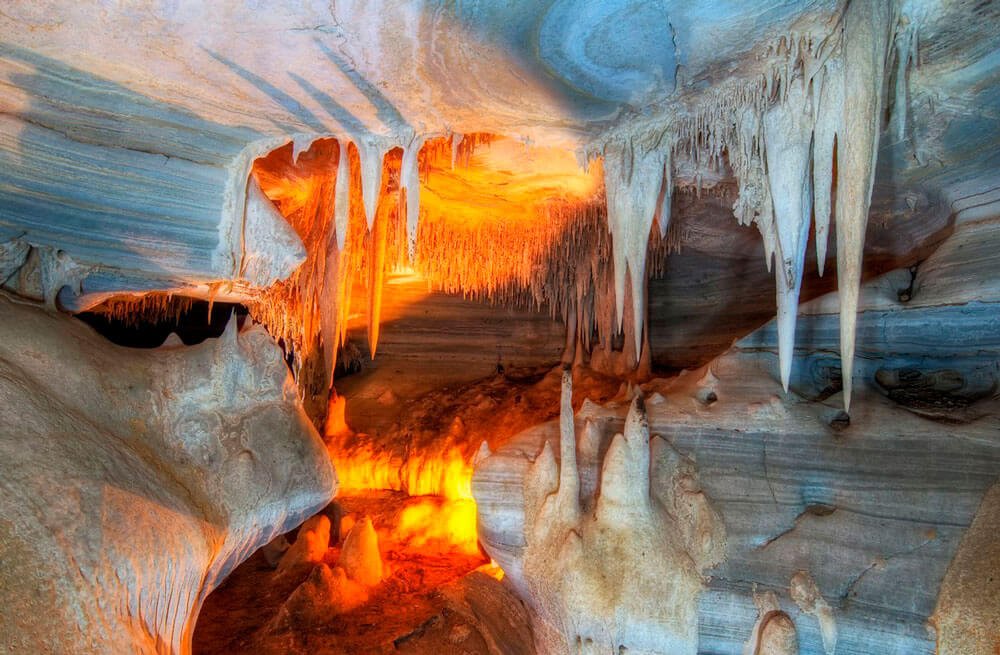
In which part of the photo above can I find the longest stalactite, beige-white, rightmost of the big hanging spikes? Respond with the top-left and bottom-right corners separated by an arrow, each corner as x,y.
837,0 -> 893,410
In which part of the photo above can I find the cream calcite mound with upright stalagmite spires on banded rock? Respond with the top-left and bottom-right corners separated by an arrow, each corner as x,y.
473,372 -> 725,654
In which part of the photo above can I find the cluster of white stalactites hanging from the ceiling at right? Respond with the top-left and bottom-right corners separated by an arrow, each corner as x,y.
604,0 -> 916,408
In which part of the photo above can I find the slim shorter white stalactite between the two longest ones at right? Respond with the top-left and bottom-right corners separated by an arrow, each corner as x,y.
813,57 -> 844,275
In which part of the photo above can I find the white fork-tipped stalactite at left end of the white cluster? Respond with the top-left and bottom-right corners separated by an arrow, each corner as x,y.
604,141 -> 665,361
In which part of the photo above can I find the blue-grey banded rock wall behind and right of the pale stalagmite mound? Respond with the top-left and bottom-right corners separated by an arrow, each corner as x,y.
473,220 -> 1000,655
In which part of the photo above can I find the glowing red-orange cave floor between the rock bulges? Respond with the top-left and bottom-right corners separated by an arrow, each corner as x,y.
193,366 -> 625,655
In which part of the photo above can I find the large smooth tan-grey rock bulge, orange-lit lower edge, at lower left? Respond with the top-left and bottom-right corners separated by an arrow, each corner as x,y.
0,296 -> 335,655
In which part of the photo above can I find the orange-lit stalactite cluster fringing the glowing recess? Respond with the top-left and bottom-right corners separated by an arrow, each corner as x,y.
247,128 -> 677,404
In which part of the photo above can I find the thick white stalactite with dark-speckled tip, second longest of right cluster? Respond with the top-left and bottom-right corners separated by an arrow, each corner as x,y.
764,80 -> 812,391
